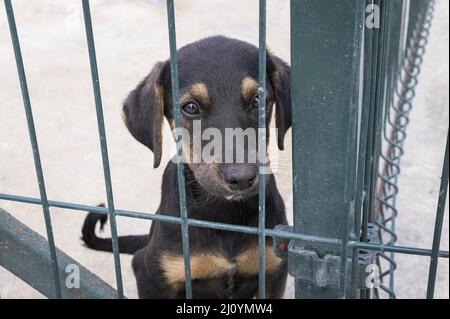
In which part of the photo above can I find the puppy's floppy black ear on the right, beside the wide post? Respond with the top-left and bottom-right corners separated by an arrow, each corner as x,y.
268,55 -> 292,150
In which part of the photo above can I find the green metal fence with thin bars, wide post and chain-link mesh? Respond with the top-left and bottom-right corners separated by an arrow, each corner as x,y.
0,0 -> 449,298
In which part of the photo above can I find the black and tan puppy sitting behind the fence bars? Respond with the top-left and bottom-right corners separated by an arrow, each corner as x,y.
82,36 -> 291,298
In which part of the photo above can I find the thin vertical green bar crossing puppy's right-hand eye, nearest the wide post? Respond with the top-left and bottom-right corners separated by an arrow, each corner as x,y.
258,0 -> 267,299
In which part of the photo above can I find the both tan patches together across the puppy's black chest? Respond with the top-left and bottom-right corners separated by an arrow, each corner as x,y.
160,246 -> 281,286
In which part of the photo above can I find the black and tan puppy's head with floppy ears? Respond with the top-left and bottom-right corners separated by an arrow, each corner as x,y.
123,36 -> 291,199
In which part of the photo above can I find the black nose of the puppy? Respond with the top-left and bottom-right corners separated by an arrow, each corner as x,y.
222,164 -> 257,190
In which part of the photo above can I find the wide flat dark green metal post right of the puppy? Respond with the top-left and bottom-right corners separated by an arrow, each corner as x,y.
291,0 -> 361,298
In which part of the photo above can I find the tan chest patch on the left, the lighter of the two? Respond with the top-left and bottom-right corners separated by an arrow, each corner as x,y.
160,253 -> 233,286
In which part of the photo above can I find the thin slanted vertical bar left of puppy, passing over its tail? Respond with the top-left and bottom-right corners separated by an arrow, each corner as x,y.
82,0 -> 123,298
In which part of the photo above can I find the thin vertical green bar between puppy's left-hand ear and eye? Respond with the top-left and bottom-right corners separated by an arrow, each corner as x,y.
167,0 -> 192,299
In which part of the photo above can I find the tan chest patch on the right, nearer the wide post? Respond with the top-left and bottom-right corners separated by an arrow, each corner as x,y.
236,246 -> 281,276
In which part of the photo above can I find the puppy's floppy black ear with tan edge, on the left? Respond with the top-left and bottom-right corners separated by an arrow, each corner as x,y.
123,62 -> 167,168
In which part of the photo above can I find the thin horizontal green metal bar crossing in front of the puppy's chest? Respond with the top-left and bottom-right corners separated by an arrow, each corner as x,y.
0,193 -> 449,258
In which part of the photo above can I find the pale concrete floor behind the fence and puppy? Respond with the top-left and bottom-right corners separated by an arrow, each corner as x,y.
0,0 -> 449,298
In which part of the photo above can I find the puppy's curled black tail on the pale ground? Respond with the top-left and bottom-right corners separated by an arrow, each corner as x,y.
81,204 -> 149,254
